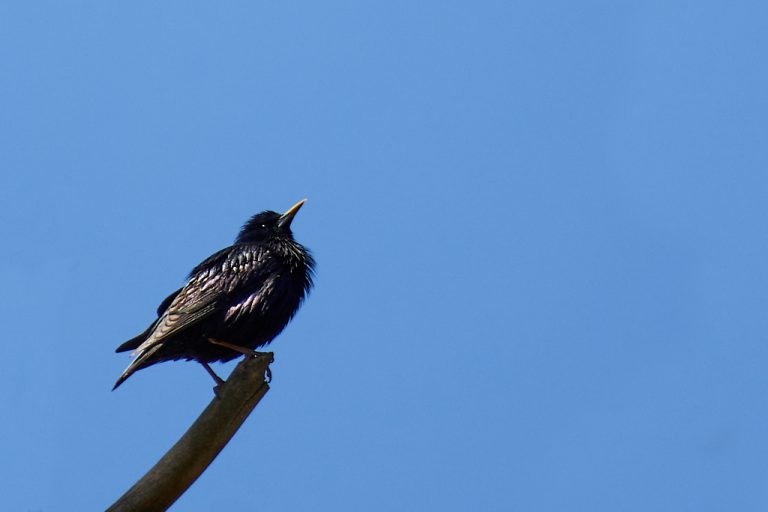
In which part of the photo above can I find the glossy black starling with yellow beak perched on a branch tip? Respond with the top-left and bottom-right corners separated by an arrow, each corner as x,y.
112,200 -> 315,390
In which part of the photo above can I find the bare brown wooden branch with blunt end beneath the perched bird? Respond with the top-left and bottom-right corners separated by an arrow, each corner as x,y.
107,352 -> 272,512
